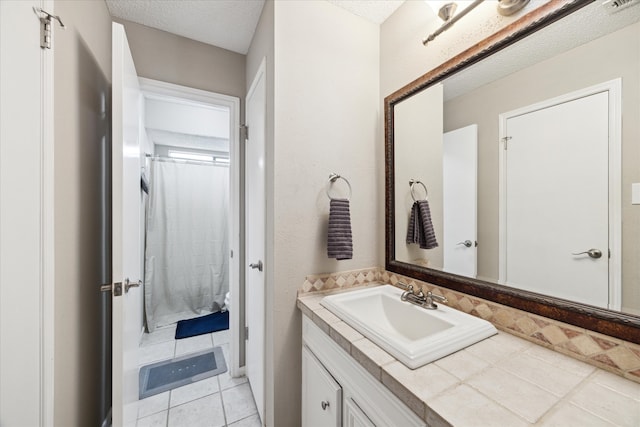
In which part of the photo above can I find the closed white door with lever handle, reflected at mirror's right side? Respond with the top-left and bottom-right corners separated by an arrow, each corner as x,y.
501,92 -> 609,308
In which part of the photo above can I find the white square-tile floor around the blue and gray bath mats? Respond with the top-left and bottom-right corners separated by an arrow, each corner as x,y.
137,325 -> 262,427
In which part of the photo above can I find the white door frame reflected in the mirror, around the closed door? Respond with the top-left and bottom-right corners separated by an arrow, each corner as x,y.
498,78 -> 622,310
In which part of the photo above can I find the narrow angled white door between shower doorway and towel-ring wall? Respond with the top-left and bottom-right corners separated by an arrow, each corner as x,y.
245,60 -> 267,423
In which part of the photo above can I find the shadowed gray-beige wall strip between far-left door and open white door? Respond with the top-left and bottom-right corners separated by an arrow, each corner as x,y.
53,0 -> 111,426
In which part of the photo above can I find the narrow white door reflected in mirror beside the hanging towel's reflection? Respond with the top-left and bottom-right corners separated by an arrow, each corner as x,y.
442,125 -> 478,277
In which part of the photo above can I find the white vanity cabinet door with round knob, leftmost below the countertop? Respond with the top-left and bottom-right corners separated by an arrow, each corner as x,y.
302,346 -> 342,427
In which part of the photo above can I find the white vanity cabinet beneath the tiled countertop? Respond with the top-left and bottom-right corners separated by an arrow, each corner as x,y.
302,316 -> 426,427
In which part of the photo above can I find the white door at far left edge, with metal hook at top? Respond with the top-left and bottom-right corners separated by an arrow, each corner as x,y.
0,0 -> 53,426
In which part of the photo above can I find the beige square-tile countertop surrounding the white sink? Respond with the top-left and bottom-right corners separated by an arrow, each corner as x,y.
297,288 -> 640,427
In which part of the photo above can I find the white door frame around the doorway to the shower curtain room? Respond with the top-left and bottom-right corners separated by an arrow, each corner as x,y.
138,77 -> 244,377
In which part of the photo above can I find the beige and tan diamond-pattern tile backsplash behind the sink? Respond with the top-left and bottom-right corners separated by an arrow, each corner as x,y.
299,267 -> 640,383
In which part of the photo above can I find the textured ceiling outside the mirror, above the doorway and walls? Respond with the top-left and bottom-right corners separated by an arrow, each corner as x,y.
106,0 -> 404,54
